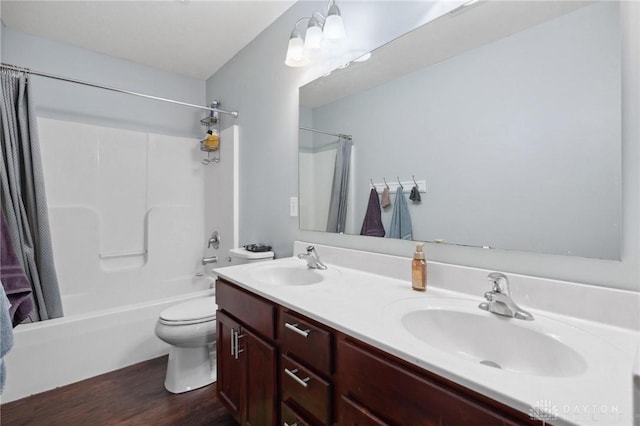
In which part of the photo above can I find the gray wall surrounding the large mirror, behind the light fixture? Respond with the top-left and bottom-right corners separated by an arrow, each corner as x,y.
206,2 -> 640,290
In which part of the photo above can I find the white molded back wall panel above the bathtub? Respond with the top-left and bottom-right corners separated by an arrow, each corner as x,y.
38,118 -> 205,306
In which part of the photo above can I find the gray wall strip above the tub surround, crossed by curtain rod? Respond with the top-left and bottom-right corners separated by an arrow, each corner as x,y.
2,26 -> 206,137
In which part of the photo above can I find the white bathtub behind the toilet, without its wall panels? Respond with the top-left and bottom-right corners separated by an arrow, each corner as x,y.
2,276 -> 214,403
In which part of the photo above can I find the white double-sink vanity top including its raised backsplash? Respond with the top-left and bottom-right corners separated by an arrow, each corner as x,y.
216,242 -> 640,426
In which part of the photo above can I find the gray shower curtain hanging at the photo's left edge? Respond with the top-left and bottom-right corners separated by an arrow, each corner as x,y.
0,69 -> 62,321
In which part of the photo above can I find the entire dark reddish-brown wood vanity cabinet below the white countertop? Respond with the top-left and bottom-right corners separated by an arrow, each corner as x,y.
216,280 -> 541,426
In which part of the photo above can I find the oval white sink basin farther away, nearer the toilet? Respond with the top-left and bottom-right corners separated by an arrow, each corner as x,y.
250,262 -> 340,286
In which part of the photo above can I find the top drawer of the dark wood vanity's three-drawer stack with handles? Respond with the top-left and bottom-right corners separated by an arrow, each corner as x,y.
279,312 -> 332,376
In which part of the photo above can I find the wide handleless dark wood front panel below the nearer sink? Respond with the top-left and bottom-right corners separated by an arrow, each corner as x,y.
336,340 -> 517,426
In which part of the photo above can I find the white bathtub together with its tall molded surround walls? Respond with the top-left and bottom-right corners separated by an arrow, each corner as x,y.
2,118 -> 238,402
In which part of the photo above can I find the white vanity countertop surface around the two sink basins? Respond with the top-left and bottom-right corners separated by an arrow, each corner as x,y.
214,241 -> 640,426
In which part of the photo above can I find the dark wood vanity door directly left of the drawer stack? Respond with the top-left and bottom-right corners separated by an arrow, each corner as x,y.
244,329 -> 277,426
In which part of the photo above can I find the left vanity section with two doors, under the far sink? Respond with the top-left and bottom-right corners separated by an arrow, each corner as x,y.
216,280 -> 278,425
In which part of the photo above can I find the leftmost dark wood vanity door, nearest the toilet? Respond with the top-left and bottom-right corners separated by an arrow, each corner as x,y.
216,311 -> 246,423
